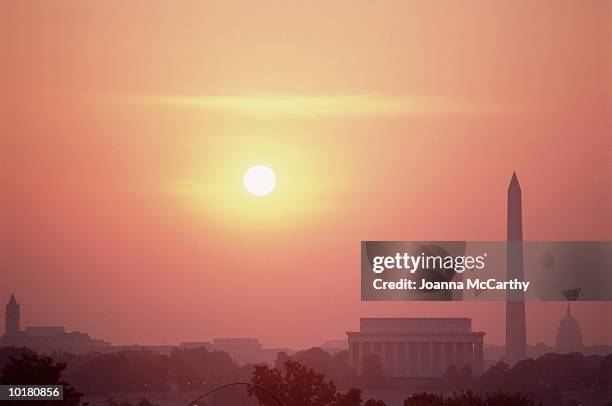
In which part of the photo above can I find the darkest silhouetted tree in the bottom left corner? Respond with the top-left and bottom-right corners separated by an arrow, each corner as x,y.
0,353 -> 83,406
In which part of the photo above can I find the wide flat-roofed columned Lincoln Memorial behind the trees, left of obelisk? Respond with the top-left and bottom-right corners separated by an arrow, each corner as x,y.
346,318 -> 485,378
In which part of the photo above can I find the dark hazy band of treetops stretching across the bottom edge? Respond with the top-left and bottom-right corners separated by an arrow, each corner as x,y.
0,347 -> 612,406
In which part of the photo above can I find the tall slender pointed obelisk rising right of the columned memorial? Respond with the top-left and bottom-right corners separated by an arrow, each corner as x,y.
506,172 -> 527,365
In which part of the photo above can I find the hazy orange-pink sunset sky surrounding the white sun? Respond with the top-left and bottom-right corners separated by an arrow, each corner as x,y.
0,0 -> 612,347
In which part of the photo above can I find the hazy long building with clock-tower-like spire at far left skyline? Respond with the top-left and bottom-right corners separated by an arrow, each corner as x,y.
0,295 -> 111,354
